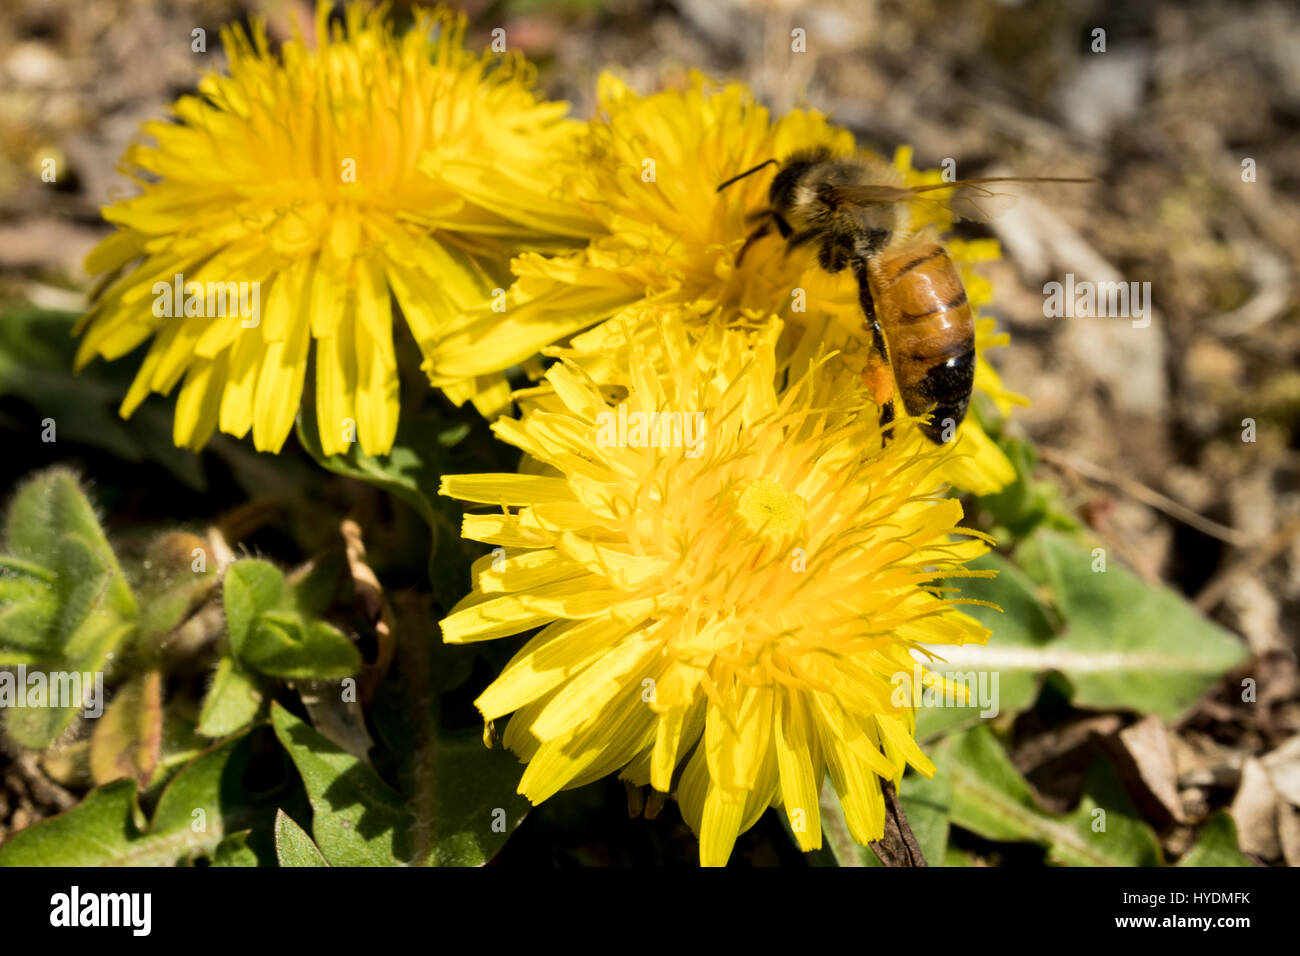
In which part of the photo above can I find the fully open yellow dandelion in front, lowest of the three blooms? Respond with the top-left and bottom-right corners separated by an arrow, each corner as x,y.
442,320 -> 988,865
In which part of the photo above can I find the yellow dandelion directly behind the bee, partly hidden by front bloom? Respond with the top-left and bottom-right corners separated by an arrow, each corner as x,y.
457,74 -> 1014,493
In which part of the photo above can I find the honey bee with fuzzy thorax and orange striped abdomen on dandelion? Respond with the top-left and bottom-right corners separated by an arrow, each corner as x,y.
718,147 -> 1088,444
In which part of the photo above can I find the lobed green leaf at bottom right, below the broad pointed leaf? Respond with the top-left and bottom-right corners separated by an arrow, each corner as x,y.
946,727 -> 1161,866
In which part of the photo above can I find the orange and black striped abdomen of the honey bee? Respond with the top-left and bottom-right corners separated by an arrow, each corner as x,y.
867,241 -> 975,442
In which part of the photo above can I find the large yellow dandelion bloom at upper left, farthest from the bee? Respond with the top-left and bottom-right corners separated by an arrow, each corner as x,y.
78,3 -> 589,454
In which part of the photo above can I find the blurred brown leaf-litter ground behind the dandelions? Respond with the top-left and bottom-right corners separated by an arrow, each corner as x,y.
0,0 -> 1300,865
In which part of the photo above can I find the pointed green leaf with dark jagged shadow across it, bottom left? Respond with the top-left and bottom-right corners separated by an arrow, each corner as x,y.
270,704 -> 415,866
